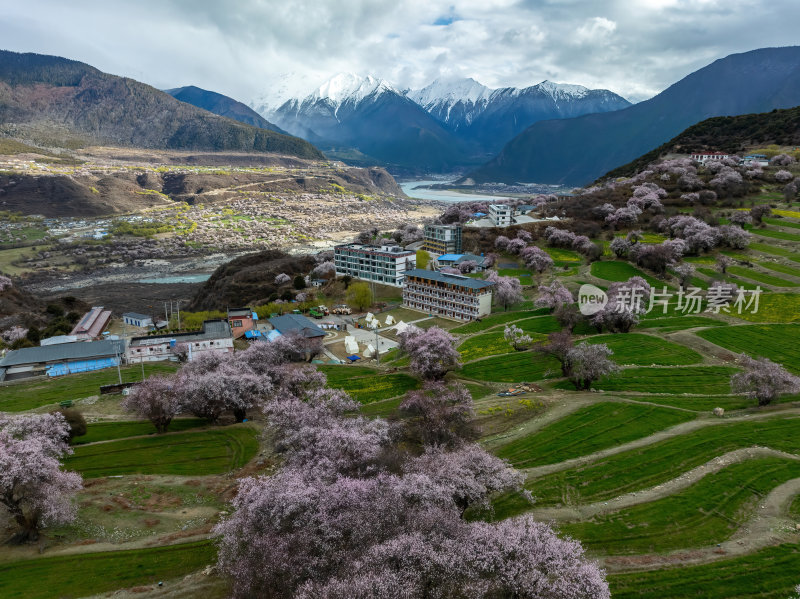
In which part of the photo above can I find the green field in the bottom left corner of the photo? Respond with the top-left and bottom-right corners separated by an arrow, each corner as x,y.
0,541 -> 217,599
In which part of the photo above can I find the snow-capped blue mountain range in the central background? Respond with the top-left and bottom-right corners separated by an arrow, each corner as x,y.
251,73 -> 630,170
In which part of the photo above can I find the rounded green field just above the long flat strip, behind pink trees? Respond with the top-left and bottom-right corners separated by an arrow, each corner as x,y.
587,333 -> 703,366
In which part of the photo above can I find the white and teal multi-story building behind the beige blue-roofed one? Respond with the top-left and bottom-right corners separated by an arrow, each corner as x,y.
333,243 -> 417,287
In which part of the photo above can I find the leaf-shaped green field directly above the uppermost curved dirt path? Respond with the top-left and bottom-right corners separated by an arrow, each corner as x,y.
494,402 -> 695,468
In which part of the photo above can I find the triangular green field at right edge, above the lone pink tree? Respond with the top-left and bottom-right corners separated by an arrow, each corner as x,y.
696,324 -> 800,374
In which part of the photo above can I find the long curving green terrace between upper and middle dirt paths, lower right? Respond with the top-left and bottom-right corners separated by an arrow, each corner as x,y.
497,417 -> 800,516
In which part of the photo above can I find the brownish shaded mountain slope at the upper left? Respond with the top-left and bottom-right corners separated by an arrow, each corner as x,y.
0,51 -> 323,158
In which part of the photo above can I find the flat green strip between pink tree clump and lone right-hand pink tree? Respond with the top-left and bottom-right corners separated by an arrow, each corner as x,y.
556,366 -> 736,395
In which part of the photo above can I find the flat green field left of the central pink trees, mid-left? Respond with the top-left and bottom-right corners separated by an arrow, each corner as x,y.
65,425 -> 258,478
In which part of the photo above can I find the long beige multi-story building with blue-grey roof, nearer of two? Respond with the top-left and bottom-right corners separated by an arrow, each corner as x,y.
403,269 -> 494,320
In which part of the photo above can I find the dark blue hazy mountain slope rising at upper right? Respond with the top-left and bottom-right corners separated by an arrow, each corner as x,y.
469,47 -> 800,185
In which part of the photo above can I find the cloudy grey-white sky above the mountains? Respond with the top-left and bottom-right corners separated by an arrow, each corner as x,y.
0,0 -> 800,102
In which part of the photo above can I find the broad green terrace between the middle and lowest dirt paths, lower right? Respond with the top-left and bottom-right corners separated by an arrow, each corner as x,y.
559,458 -> 800,555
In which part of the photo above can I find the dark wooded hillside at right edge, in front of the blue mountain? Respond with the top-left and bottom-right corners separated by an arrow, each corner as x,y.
605,106 -> 800,177
